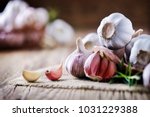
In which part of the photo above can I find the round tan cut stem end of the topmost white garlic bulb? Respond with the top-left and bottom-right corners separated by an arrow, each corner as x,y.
102,23 -> 115,40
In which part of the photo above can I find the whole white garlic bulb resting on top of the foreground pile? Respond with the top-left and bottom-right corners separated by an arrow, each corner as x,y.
97,13 -> 135,49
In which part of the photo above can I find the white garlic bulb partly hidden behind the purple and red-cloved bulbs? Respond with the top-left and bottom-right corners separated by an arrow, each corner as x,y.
82,32 -> 103,51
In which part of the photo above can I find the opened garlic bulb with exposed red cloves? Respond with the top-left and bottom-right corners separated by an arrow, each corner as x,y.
84,46 -> 118,81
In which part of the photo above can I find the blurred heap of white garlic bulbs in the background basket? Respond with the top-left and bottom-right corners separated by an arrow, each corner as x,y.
0,0 -> 48,32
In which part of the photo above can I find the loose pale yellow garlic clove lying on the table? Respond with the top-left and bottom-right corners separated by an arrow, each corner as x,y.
22,70 -> 41,82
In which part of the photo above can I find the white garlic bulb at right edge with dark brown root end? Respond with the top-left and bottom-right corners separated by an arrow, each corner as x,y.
129,34 -> 150,69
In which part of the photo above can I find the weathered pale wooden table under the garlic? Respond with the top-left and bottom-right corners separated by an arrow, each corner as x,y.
0,29 -> 150,100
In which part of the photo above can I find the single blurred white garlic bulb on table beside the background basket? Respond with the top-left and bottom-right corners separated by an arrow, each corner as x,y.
46,19 -> 75,45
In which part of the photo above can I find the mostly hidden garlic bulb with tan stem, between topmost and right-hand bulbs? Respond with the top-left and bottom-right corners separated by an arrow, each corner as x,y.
125,29 -> 143,62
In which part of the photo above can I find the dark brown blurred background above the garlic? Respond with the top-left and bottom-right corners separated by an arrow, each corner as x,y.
0,0 -> 150,30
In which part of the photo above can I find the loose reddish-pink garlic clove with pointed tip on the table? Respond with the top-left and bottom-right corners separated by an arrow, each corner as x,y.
45,64 -> 62,81
